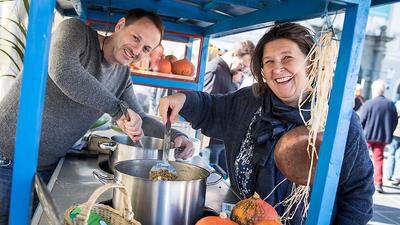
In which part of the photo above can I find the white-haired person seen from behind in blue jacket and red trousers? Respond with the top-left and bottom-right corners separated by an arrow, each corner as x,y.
360,80 -> 397,193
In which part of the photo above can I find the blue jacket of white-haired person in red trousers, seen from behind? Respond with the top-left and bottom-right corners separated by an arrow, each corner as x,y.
360,96 -> 398,144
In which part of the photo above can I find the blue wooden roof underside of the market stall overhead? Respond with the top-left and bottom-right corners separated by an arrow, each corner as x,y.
56,0 -> 395,37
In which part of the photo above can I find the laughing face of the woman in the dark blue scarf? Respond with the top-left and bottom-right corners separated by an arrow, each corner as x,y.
262,38 -> 307,107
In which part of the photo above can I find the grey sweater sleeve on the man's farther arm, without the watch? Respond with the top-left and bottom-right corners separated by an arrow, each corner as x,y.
121,80 -> 186,140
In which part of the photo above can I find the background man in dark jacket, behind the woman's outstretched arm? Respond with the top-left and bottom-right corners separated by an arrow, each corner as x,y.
203,40 -> 255,171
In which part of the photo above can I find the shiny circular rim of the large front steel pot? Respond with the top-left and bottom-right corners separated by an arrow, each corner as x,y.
114,159 -> 211,184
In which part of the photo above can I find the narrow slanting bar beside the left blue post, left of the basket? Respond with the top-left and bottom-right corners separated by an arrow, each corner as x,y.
35,173 -> 62,225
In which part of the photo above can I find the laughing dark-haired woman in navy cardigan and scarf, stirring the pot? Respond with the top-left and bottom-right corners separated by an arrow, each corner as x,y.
160,23 -> 374,225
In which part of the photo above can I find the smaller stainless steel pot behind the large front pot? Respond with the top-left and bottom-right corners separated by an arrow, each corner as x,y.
99,135 -> 163,172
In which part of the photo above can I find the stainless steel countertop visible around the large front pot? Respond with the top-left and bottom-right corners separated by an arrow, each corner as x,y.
32,157 -> 238,225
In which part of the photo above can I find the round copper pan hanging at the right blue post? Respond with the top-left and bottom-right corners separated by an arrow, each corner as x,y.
274,126 -> 322,185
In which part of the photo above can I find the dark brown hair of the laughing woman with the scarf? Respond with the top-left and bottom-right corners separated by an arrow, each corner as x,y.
251,23 -> 314,95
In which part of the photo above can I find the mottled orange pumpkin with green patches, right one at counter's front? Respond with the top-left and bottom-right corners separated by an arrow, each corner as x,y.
231,193 -> 281,225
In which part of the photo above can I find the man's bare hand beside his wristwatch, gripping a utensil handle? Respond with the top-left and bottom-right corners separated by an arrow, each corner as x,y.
117,109 -> 143,141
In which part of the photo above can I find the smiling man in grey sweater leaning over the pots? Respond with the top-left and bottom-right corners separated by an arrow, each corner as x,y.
0,9 -> 194,224
